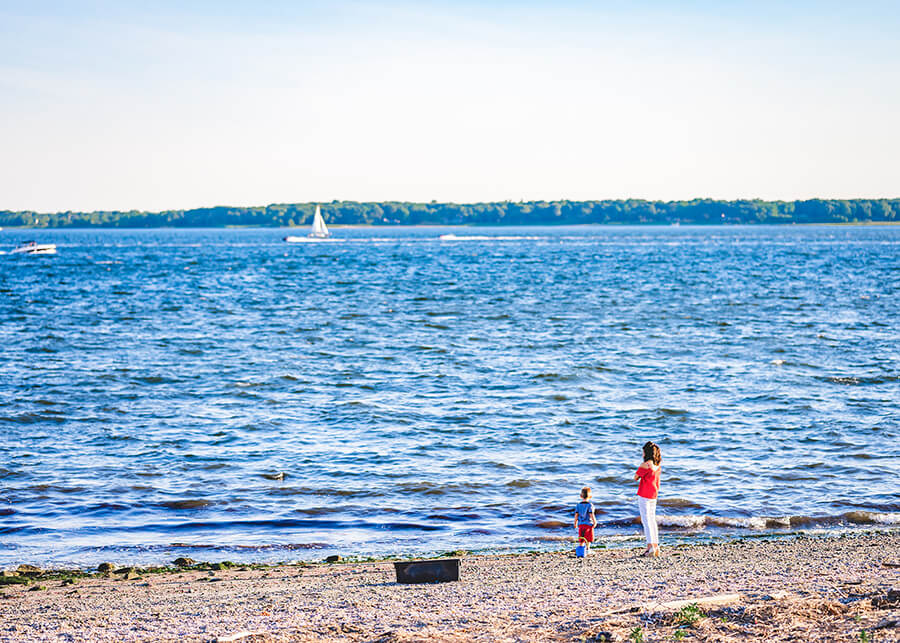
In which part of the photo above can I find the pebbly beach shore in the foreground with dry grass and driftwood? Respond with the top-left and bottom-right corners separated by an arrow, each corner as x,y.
0,532 -> 900,642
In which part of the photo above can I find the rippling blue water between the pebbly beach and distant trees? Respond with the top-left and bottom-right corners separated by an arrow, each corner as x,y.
0,226 -> 900,566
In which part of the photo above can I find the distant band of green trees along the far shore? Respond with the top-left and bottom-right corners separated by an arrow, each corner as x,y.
0,199 -> 900,228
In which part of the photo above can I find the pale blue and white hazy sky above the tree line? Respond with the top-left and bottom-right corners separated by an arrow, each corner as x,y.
0,0 -> 900,212
